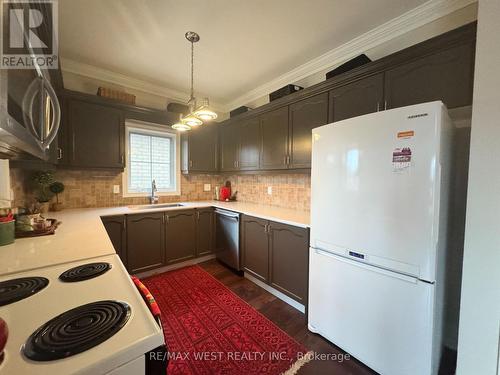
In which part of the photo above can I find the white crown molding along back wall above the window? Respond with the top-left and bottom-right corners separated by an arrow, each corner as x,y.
61,57 -> 225,111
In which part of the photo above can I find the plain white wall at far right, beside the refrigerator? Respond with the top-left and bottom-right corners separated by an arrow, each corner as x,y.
457,0 -> 500,375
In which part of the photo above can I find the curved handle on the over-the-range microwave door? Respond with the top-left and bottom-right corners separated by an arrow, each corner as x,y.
23,77 -> 61,151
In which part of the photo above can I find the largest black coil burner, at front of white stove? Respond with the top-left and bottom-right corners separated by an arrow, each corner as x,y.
23,301 -> 131,361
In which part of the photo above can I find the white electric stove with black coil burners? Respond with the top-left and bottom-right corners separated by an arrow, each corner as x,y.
0,255 -> 164,375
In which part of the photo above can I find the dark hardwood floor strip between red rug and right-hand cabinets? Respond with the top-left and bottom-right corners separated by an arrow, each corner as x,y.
199,260 -> 375,375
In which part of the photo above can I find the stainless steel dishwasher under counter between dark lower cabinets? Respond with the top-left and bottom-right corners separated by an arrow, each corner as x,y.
215,208 -> 241,271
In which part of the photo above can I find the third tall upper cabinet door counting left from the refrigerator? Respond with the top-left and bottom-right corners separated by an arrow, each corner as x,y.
238,117 -> 260,170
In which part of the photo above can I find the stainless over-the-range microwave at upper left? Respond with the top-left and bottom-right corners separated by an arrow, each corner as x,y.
0,1 -> 61,160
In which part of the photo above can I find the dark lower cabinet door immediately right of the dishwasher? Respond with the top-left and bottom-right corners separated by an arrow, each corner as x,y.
241,215 -> 269,283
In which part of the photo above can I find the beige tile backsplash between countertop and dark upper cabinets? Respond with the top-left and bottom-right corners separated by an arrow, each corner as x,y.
11,168 -> 311,210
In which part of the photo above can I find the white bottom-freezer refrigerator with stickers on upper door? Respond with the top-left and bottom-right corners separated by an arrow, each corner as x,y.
308,102 -> 453,375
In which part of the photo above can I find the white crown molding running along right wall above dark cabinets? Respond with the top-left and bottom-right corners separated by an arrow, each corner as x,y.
226,0 -> 477,111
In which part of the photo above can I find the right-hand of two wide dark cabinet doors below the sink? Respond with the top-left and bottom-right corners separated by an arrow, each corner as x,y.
165,210 -> 196,264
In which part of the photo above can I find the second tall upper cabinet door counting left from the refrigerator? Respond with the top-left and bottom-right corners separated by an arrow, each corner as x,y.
260,107 -> 288,169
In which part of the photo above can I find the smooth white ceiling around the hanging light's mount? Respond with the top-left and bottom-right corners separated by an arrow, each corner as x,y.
59,0 -> 425,103
